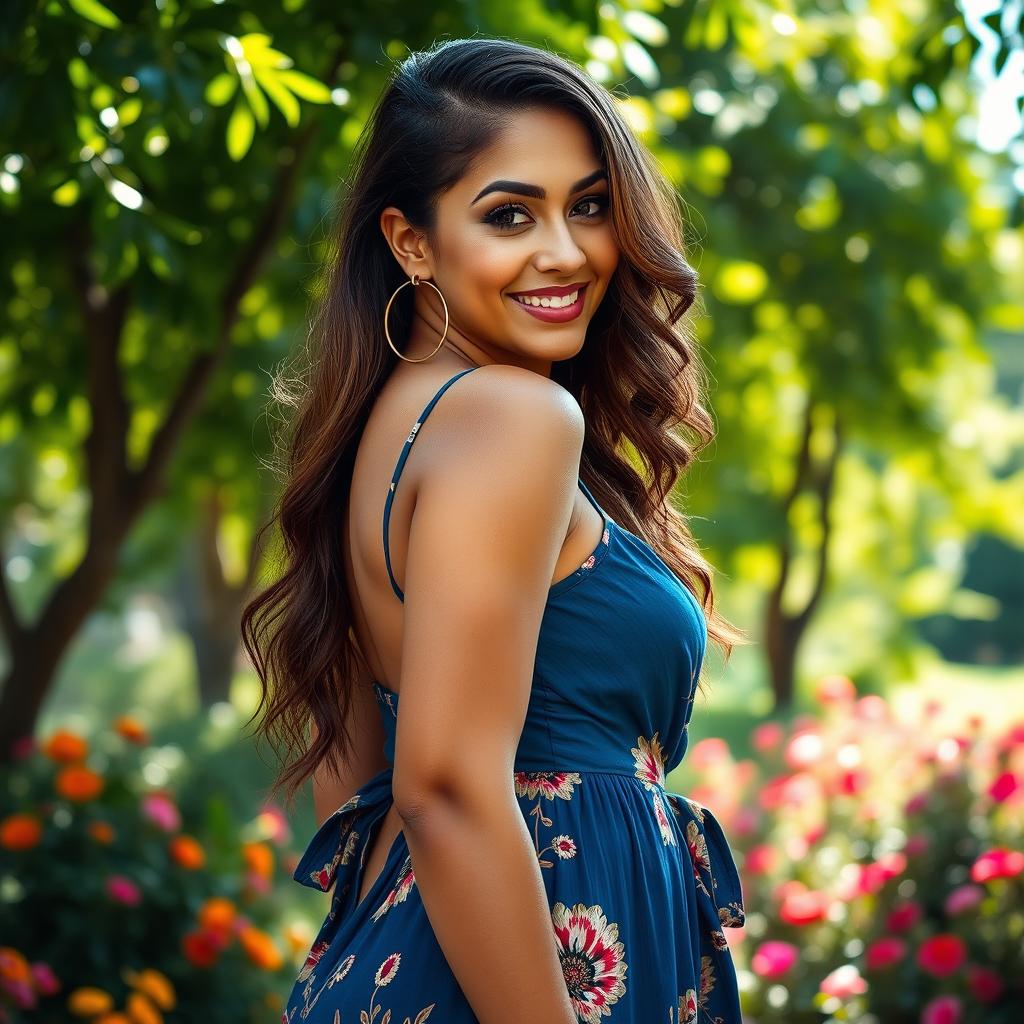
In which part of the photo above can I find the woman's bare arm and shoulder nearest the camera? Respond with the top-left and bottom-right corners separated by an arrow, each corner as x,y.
393,366 -> 585,1024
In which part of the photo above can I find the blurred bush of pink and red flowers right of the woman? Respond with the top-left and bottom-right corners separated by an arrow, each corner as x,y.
686,676 -> 1024,1024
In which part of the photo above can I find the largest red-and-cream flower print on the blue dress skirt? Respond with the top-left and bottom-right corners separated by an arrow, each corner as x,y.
551,902 -> 628,1024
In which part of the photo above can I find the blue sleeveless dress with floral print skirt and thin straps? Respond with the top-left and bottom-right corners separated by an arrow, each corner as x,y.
282,367 -> 744,1024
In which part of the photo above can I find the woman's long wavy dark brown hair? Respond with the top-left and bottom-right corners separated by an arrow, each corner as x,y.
242,37 -> 746,803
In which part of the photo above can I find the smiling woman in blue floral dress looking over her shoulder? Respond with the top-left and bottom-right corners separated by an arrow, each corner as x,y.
243,38 -> 743,1024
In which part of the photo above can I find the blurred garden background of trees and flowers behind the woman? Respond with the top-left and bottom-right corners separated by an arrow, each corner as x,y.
0,0 -> 1024,1024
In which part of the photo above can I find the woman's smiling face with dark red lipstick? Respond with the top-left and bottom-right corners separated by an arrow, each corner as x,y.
382,108 -> 618,376
